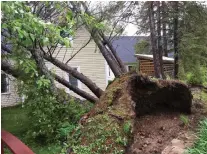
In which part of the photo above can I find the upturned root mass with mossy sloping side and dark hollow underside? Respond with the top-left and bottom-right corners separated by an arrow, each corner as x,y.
68,72 -> 192,154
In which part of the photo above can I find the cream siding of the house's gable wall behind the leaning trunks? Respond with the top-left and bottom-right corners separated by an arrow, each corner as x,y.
47,29 -> 107,98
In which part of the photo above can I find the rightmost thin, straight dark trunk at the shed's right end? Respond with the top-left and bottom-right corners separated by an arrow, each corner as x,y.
173,1 -> 179,79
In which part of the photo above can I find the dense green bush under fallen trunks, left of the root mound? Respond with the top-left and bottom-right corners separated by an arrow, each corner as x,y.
24,92 -> 91,143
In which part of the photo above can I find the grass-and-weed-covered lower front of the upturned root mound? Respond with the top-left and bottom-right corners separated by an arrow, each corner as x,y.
68,114 -> 128,154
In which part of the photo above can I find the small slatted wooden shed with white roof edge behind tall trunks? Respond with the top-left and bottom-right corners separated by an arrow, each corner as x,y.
135,54 -> 174,77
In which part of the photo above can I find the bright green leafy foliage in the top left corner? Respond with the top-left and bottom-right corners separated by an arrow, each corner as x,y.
2,2 -> 74,50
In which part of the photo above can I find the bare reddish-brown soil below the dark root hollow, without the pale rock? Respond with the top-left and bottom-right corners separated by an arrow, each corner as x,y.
127,86 -> 207,154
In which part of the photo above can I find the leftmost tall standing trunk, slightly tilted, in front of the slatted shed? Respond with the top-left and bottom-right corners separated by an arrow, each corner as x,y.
147,2 -> 162,78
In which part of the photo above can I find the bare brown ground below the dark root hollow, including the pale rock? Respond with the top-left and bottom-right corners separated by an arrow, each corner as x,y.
127,86 -> 207,154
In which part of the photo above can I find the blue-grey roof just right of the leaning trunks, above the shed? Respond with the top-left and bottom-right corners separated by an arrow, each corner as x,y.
112,36 -> 148,63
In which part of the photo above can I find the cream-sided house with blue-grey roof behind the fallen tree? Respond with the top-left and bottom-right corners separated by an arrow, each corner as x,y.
1,28 -> 147,106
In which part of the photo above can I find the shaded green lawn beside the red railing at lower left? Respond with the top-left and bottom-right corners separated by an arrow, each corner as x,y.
1,106 -> 61,154
